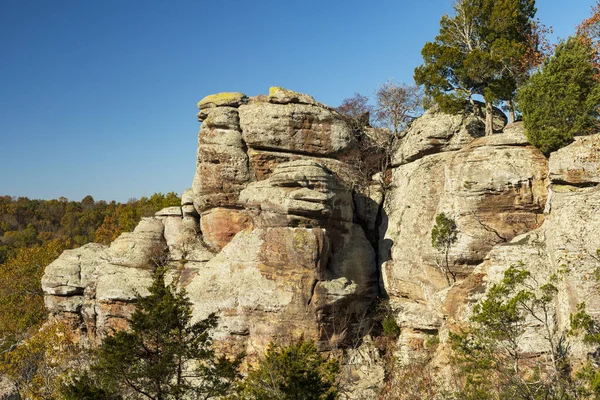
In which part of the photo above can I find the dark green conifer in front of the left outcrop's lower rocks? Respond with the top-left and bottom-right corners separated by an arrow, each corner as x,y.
65,268 -> 241,400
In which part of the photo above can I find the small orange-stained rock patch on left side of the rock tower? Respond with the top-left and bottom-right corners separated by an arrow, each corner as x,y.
200,207 -> 252,250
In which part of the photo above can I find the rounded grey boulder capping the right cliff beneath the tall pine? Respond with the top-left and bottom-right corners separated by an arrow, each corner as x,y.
392,103 -> 506,165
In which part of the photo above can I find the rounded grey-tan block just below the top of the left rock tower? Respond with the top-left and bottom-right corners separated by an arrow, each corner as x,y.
239,103 -> 354,156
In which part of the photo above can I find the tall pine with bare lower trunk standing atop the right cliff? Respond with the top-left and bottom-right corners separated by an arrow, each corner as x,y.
415,0 -> 537,135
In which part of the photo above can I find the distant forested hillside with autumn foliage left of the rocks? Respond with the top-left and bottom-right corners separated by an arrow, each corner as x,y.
0,192 -> 181,349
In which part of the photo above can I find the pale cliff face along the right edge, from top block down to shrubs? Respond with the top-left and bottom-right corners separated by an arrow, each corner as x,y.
446,135 -> 600,360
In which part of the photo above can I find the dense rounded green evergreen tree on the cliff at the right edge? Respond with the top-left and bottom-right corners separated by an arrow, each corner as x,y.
518,37 -> 600,154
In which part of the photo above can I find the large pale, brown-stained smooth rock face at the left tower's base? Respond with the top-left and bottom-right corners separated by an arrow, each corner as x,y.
186,228 -> 328,354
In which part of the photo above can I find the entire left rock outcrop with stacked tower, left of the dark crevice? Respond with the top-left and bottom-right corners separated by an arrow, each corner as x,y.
43,88 -> 379,357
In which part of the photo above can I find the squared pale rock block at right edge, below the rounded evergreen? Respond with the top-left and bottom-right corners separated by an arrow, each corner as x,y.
550,134 -> 600,185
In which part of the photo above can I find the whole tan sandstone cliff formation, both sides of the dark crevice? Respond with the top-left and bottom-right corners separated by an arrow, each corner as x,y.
42,88 -> 600,398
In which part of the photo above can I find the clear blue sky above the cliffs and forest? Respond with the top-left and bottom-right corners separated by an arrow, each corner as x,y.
0,0 -> 594,201
